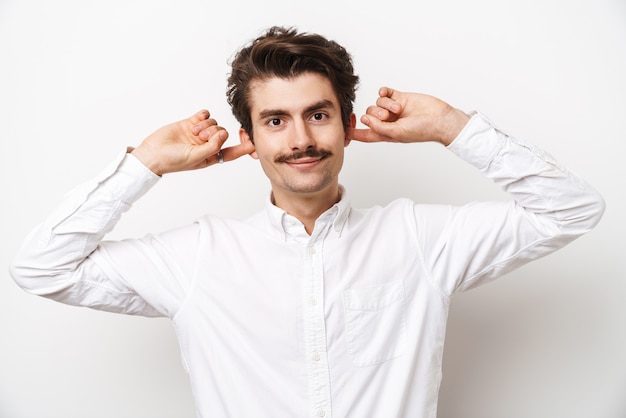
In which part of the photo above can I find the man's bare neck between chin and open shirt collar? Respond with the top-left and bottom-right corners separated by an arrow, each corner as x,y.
272,185 -> 341,235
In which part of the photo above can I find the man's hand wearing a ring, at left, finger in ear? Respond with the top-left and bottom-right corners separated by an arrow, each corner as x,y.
131,110 -> 254,175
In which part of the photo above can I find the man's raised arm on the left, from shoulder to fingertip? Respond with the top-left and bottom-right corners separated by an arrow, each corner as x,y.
10,110 -> 254,315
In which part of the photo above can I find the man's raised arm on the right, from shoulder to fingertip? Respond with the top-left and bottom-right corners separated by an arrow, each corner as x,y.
347,88 -> 604,294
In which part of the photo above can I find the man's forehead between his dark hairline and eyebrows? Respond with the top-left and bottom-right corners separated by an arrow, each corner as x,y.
250,73 -> 339,119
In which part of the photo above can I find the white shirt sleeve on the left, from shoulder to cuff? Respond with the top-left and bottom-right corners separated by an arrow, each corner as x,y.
10,152 -> 190,316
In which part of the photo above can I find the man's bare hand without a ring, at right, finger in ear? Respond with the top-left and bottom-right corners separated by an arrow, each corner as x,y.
346,87 -> 469,146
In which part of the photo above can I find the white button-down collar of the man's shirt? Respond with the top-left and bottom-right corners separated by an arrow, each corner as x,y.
266,185 -> 350,240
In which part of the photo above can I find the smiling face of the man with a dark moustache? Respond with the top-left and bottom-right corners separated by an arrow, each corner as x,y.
240,73 -> 356,204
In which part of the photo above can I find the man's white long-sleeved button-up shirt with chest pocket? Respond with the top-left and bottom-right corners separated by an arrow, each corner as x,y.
11,114 -> 604,418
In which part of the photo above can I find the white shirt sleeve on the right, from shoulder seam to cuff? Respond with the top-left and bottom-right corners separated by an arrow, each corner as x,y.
414,113 -> 605,295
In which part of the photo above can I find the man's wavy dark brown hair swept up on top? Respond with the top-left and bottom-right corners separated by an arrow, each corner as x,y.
226,26 -> 359,137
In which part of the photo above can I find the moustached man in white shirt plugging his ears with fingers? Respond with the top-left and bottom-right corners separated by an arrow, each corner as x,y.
11,28 -> 604,418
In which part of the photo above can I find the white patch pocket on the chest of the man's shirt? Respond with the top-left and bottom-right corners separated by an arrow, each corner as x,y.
343,280 -> 407,367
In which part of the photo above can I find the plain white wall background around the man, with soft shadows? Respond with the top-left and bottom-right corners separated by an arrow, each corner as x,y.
0,0 -> 626,418
